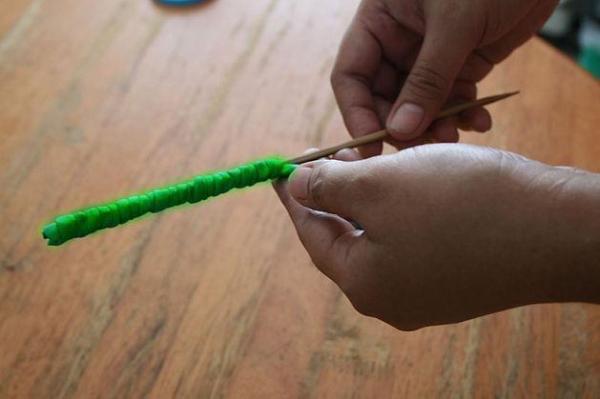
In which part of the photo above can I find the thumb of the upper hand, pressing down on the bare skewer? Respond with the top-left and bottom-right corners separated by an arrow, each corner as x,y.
387,21 -> 474,141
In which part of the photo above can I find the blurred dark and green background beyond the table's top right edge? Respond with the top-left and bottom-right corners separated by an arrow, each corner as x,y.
540,0 -> 600,78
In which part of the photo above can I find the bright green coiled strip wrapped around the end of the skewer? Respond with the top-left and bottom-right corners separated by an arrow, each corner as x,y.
42,157 -> 295,245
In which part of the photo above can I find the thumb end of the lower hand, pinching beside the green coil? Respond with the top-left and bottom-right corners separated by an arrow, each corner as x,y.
288,161 -> 367,223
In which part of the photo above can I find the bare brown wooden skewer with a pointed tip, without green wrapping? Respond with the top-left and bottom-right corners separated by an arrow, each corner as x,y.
289,91 -> 519,164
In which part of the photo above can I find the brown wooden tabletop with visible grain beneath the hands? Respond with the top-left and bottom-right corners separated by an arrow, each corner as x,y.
0,0 -> 600,398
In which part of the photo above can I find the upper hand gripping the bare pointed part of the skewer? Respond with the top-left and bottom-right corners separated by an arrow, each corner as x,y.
331,0 -> 558,156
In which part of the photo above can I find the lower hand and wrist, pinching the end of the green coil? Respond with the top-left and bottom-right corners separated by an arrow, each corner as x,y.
276,144 -> 600,330
